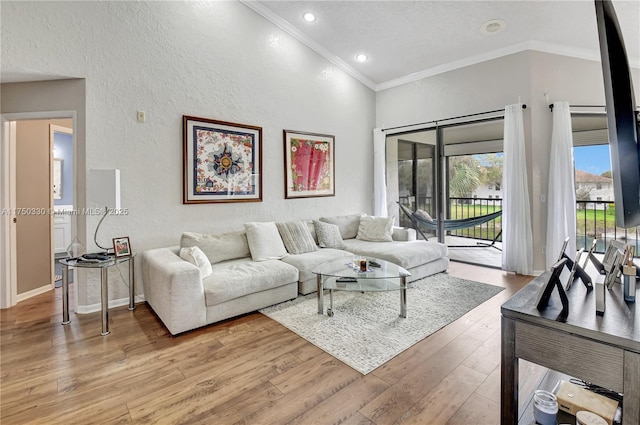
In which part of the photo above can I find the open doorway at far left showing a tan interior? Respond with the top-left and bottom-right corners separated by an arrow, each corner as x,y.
2,112 -> 75,308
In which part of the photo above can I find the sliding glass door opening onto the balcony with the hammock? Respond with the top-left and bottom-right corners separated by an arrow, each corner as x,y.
387,116 -> 504,267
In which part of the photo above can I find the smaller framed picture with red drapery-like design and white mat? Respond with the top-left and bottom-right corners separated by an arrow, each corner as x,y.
284,130 -> 336,199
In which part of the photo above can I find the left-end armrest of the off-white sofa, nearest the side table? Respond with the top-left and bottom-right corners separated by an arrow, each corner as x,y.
142,248 -> 207,335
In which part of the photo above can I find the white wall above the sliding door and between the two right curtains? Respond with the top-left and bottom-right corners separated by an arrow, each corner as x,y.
376,51 -> 640,272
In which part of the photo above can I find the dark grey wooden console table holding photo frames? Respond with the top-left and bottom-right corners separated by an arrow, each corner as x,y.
501,271 -> 640,425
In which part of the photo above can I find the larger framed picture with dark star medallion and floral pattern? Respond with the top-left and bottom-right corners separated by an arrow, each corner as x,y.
182,115 -> 262,204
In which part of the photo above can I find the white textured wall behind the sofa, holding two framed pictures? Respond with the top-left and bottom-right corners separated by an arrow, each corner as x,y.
1,1 -> 375,305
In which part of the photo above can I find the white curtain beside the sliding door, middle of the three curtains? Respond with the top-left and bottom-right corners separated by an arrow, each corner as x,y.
502,103 -> 533,275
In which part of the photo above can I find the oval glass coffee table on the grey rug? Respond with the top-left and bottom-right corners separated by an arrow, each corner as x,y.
312,256 -> 411,318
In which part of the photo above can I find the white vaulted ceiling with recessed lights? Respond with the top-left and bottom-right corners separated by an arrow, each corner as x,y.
248,0 -> 640,90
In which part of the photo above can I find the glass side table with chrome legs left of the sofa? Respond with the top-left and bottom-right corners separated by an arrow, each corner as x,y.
59,254 -> 136,336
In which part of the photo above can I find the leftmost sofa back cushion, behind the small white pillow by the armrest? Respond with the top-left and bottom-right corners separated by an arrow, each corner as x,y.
180,231 -> 251,264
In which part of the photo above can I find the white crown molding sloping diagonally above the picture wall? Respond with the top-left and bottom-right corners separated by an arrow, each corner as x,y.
239,0 -> 376,90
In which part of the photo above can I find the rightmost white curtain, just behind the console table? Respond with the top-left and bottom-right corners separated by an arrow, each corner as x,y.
546,102 -> 576,268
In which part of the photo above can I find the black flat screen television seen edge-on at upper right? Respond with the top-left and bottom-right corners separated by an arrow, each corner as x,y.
595,0 -> 640,228
